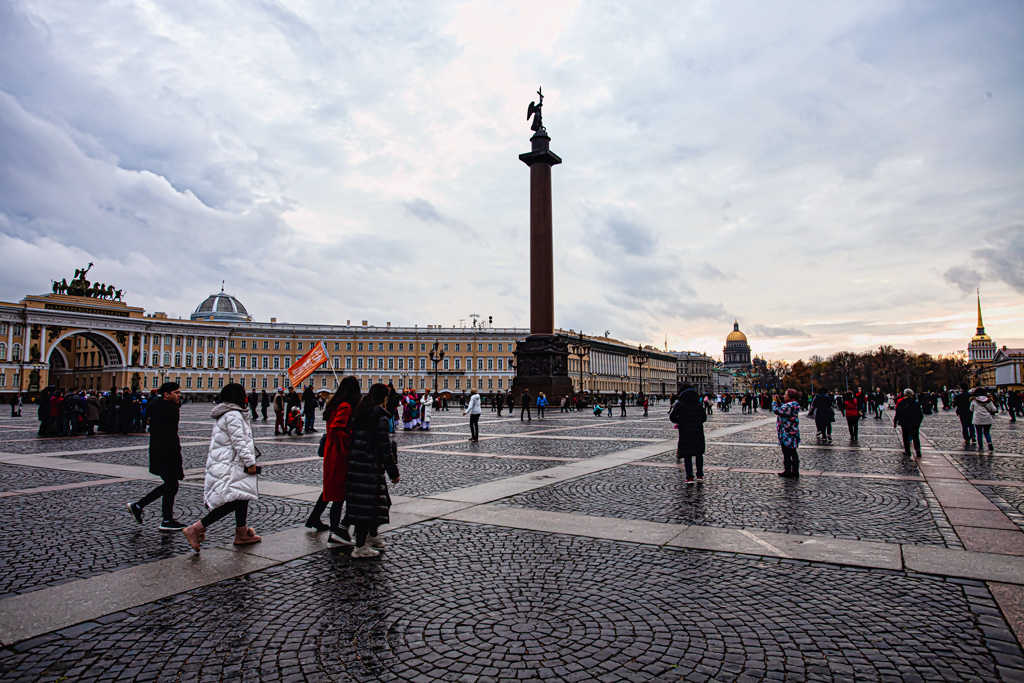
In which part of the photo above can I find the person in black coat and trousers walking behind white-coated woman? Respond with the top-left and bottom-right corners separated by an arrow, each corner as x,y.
128,382 -> 185,531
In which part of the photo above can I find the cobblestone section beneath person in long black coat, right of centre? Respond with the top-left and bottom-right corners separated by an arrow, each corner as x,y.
500,465 -> 959,547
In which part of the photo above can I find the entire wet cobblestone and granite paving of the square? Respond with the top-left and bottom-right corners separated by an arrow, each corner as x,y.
0,404 -> 1024,683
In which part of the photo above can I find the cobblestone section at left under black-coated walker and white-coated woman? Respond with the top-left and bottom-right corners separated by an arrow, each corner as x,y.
0,481 -> 309,597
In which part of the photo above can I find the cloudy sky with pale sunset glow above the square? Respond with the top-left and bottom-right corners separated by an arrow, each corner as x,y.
0,0 -> 1024,360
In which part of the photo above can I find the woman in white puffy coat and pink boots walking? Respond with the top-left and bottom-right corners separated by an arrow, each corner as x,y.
183,383 -> 262,552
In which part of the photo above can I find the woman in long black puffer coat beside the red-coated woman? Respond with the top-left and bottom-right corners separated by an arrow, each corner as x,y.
345,384 -> 398,558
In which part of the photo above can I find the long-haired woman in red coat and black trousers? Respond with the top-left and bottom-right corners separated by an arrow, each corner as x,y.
306,375 -> 359,546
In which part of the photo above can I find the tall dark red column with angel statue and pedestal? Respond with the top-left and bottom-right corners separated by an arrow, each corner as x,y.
513,88 -> 572,405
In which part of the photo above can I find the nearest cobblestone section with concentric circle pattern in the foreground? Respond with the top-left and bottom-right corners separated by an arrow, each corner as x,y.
0,522 -> 1024,681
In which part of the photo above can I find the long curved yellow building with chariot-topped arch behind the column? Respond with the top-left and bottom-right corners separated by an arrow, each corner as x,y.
0,273 -> 676,402
